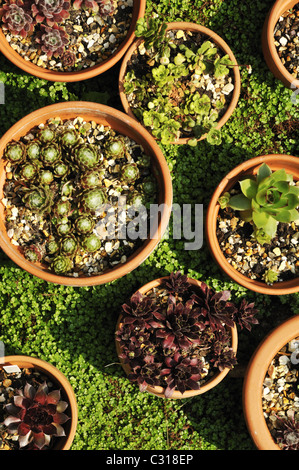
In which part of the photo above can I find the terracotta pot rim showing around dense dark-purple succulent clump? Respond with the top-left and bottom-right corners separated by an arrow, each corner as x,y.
115,276 -> 238,399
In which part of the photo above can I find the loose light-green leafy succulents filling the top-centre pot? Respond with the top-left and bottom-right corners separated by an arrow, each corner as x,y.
124,17 -> 234,145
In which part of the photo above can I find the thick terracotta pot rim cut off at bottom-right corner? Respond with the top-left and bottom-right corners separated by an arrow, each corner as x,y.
243,315 -> 299,450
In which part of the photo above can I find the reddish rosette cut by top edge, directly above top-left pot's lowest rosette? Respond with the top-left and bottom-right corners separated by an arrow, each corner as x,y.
31,0 -> 70,26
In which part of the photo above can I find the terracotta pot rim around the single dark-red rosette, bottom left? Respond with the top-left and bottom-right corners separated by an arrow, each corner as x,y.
0,355 -> 78,450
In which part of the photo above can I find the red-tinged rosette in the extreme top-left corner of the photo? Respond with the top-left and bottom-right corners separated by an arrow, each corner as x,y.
0,0 -> 34,38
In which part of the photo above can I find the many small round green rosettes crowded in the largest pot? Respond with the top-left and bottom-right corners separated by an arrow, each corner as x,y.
3,119 -> 156,275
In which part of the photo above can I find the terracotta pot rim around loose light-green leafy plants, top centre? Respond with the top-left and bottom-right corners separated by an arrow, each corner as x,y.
118,22 -> 241,144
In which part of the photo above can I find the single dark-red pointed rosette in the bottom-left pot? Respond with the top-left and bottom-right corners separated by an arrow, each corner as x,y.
3,382 -> 69,449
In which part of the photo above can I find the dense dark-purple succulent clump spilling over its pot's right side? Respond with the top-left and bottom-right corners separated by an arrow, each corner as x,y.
116,272 -> 258,398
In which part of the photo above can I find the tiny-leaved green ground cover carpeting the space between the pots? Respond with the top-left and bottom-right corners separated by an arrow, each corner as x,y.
0,0 -> 299,450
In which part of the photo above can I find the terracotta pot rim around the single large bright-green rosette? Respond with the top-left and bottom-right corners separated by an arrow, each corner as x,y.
205,154 -> 299,295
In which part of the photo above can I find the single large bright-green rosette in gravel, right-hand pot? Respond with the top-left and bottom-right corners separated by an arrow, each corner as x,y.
227,163 -> 299,244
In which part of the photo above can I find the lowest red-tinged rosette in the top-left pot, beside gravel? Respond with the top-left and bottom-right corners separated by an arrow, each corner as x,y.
36,24 -> 69,58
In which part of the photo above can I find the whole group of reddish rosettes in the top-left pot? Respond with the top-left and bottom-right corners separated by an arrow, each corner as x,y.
0,0 -> 115,58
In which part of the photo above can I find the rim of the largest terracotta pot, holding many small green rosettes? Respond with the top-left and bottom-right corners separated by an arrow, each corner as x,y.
0,101 -> 172,287
